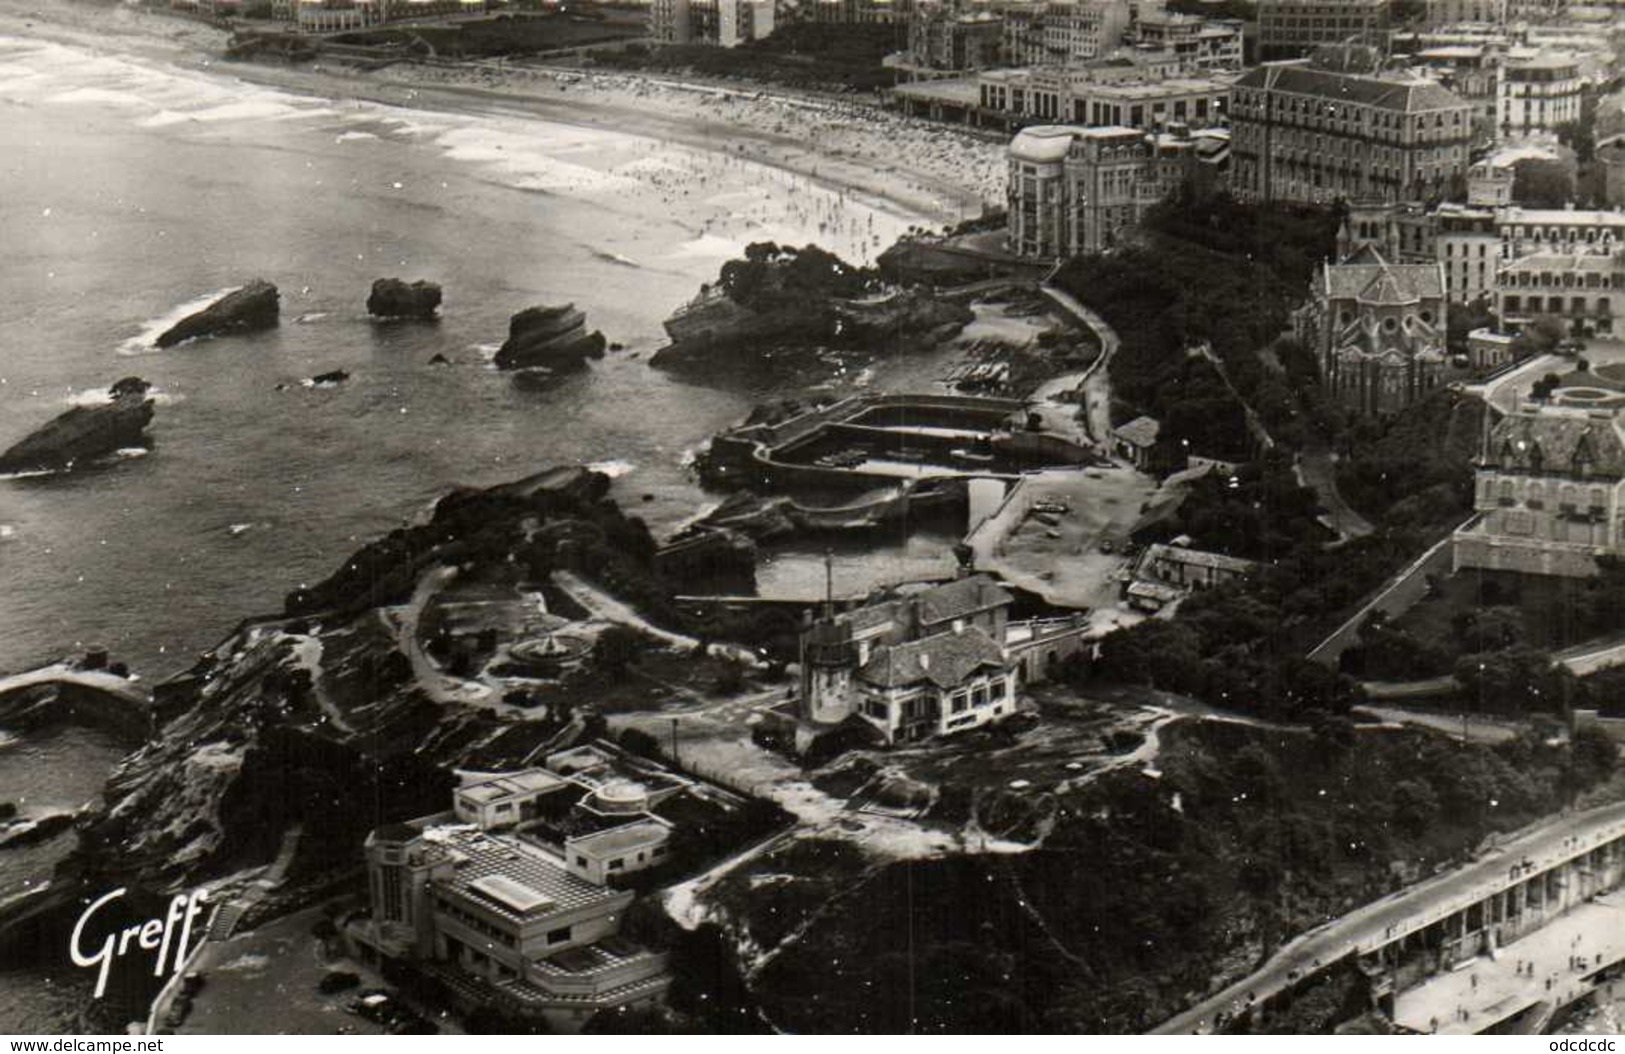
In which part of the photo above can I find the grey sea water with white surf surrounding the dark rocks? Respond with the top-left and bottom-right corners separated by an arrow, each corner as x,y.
0,26 -> 951,1031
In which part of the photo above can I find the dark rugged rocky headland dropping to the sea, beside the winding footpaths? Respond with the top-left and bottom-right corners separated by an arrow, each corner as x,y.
38,468 -> 682,902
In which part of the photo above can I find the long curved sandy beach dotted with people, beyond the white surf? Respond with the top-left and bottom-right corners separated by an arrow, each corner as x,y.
0,0 -> 1006,224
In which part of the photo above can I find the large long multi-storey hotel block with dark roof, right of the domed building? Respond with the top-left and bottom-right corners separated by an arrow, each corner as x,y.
1230,63 -> 1472,203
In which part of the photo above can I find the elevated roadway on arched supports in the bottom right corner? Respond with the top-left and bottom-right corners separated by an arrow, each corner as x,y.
1152,802 -> 1625,1035
